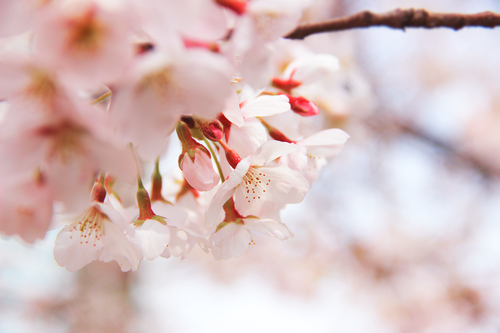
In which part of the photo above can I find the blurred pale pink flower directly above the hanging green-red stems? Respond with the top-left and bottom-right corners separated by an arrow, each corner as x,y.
110,50 -> 230,160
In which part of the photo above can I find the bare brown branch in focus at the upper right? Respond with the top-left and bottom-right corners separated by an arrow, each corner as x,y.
285,8 -> 500,39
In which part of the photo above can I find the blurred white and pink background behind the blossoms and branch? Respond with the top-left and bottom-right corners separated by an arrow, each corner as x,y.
0,0 -> 500,333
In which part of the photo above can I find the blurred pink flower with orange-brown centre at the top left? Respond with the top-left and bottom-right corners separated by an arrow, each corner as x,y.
35,0 -> 138,86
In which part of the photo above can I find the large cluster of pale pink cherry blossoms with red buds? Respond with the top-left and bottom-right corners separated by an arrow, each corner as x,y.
0,0 -> 349,271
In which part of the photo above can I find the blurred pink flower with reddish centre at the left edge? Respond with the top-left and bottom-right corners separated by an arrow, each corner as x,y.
0,76 -> 135,211
